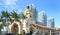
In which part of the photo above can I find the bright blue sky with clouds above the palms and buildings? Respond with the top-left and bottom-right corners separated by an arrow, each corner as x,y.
0,0 -> 60,27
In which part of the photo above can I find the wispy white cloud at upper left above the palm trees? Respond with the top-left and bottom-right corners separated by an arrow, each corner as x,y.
3,0 -> 22,13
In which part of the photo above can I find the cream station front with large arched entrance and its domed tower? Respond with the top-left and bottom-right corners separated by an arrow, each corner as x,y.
8,6 -> 35,34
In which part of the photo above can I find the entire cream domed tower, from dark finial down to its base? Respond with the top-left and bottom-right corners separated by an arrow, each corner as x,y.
24,6 -> 35,32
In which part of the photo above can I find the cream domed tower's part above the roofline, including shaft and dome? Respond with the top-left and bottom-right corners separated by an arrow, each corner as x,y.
24,6 -> 35,24
